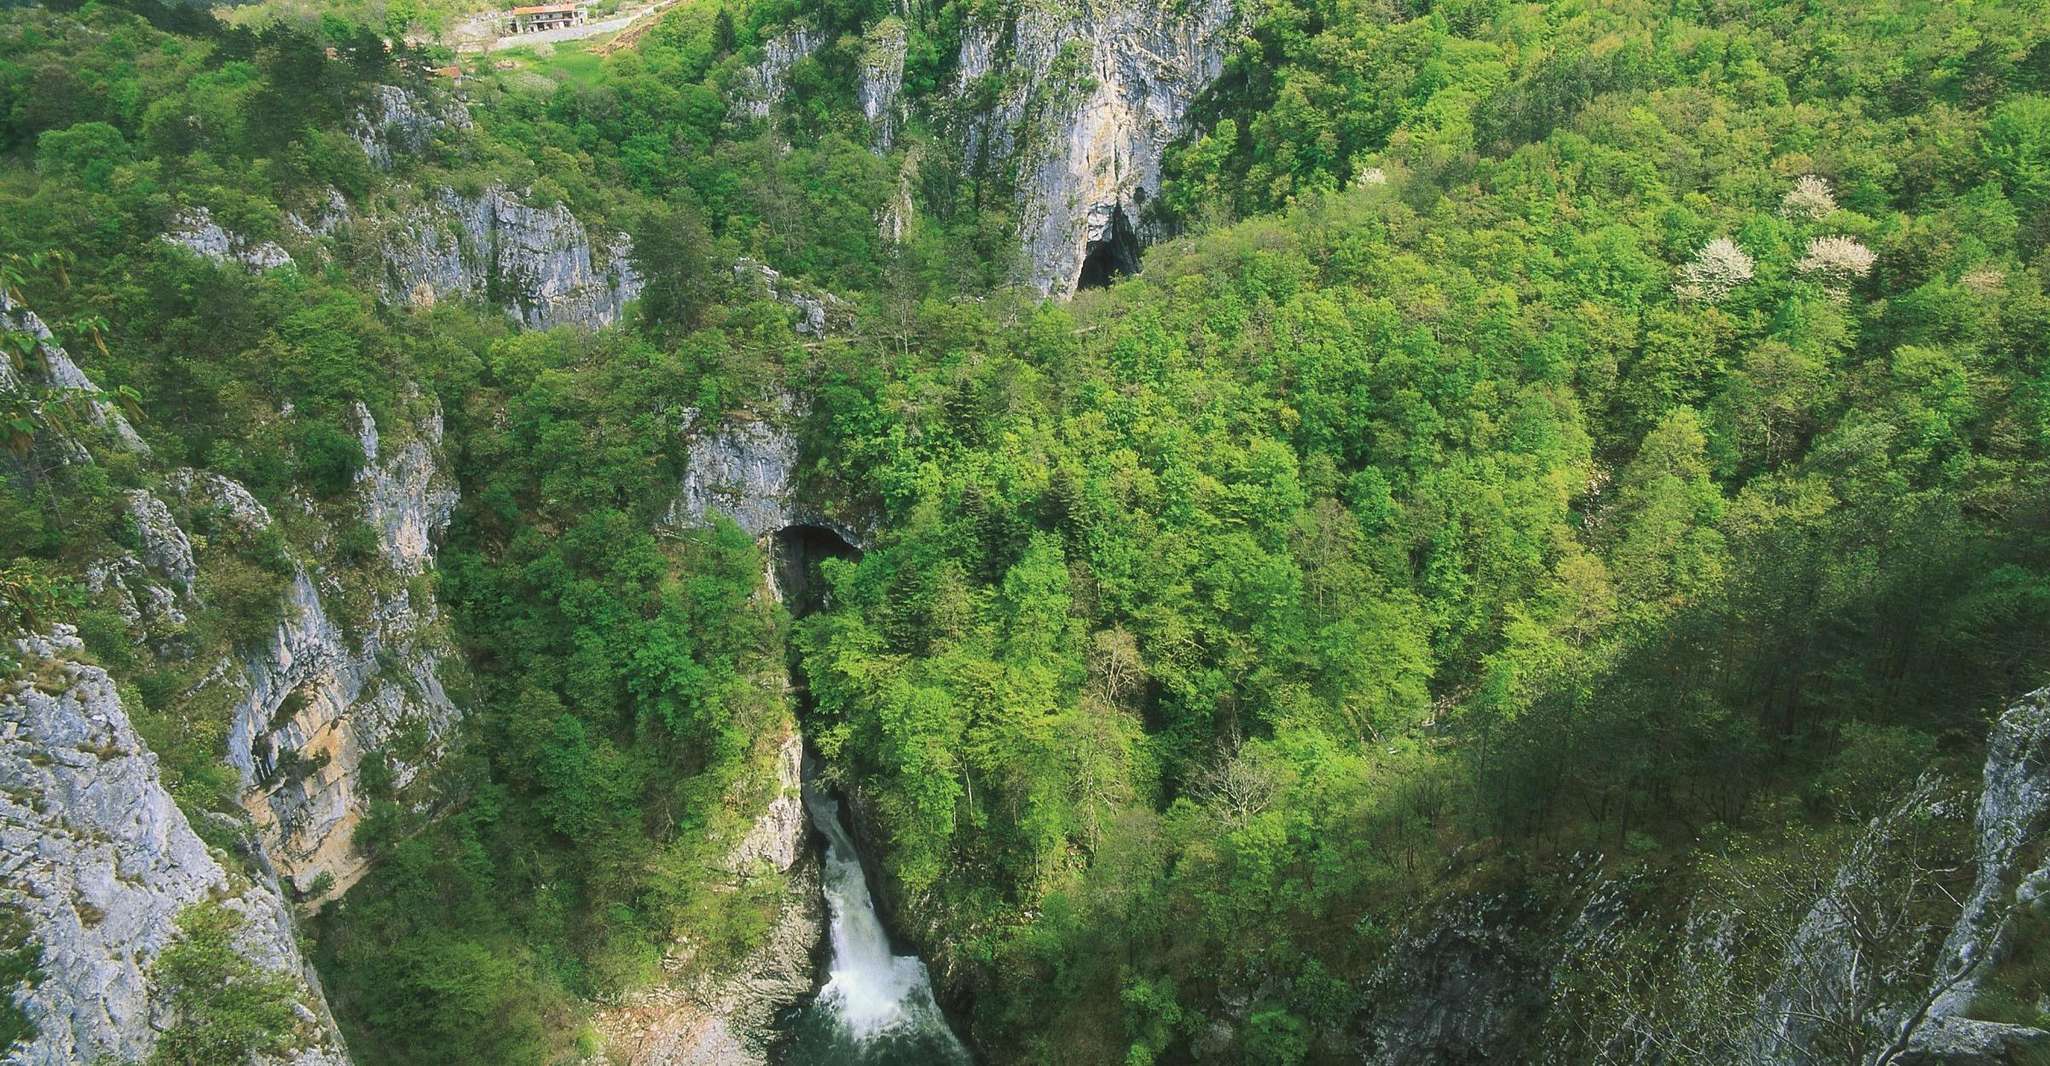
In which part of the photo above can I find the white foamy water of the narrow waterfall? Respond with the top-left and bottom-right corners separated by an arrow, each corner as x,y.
804,789 -> 970,1062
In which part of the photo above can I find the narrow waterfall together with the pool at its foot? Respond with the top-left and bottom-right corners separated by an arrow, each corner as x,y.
777,785 -> 972,1066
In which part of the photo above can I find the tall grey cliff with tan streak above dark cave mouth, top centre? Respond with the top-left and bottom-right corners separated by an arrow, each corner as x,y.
955,0 -> 1232,295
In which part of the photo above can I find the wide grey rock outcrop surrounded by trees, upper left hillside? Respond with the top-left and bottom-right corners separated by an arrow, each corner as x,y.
379,187 -> 642,328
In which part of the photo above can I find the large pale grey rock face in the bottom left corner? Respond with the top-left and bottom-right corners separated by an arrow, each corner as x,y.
0,627 -> 349,1066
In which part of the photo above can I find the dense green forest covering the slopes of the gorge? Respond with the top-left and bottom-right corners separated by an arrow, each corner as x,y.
0,0 -> 2050,1066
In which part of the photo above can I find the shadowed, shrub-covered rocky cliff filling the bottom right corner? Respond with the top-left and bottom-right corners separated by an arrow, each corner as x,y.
1336,691 -> 2050,1066
